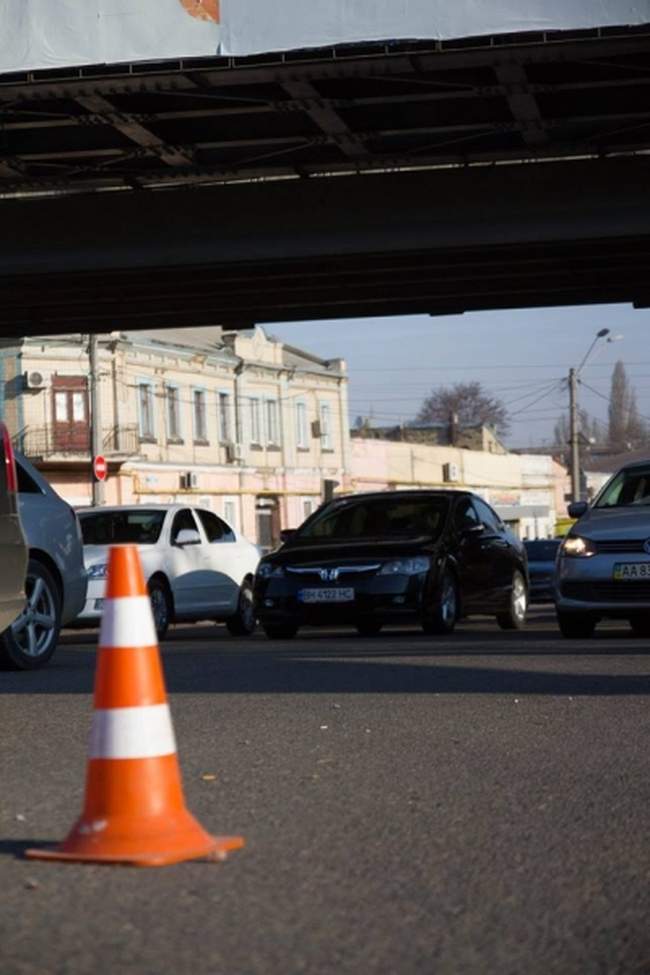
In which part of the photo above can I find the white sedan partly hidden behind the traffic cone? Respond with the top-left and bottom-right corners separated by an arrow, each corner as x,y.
77,504 -> 259,638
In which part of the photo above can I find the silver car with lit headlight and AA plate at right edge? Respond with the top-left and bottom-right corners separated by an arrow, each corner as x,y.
555,460 -> 650,638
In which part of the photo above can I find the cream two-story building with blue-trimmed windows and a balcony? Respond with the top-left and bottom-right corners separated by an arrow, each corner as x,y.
0,327 -> 350,547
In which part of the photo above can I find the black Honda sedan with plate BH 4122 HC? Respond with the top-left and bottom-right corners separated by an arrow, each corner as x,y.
254,491 -> 528,639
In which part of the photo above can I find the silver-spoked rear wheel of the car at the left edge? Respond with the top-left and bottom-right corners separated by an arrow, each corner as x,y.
0,559 -> 61,670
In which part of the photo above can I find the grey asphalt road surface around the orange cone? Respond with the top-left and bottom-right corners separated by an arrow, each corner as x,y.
0,610 -> 650,975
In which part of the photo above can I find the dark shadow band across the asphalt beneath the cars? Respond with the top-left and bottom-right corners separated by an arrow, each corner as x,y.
0,621 -> 650,696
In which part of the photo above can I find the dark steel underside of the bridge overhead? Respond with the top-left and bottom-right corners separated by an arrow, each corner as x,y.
0,30 -> 650,335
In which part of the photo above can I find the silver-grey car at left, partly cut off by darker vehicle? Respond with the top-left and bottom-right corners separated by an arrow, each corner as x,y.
0,454 -> 87,670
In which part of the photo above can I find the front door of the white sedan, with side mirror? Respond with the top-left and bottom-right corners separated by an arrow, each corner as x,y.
167,508 -> 217,618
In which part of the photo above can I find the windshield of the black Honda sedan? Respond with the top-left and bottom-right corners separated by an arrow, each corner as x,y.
294,497 -> 449,542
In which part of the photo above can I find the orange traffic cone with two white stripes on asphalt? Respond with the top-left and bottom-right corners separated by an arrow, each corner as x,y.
26,546 -> 244,867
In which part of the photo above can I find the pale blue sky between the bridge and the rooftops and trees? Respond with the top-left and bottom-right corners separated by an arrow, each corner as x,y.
265,305 -> 650,447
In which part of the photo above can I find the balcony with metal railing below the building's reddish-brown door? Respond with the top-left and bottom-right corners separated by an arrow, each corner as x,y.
13,424 -> 140,462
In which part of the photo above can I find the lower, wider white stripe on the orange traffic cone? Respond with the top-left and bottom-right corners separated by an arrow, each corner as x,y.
89,704 -> 176,758
